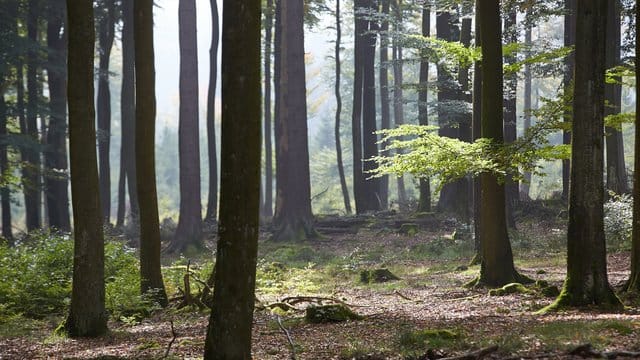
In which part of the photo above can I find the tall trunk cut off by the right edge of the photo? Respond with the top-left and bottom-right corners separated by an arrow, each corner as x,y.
625,0 -> 640,293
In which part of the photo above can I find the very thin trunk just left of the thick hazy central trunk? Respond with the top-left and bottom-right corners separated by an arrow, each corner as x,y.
261,0 -> 275,217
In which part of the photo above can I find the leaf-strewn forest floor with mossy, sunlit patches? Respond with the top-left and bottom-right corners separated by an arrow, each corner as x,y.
0,204 -> 640,360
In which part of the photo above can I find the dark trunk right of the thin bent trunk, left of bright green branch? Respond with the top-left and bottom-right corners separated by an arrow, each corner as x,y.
351,0 -> 381,214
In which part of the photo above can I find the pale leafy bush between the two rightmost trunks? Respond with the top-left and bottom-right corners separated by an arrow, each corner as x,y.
604,193 -> 633,250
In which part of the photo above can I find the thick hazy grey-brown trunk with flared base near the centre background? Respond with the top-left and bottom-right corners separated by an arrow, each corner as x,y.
273,0 -> 316,241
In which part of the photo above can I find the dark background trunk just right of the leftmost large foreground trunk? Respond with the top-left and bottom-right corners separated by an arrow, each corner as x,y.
97,0 -> 115,224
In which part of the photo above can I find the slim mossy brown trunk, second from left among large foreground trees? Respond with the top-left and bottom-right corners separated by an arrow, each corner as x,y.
133,0 -> 168,306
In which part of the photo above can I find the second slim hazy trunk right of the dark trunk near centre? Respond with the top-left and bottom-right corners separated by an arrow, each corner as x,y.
392,0 -> 408,211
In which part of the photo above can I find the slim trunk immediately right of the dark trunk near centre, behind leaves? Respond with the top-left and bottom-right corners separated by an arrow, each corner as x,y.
378,0 -> 391,209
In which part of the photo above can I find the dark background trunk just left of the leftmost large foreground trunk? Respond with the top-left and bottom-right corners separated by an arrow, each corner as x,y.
44,0 -> 71,232
